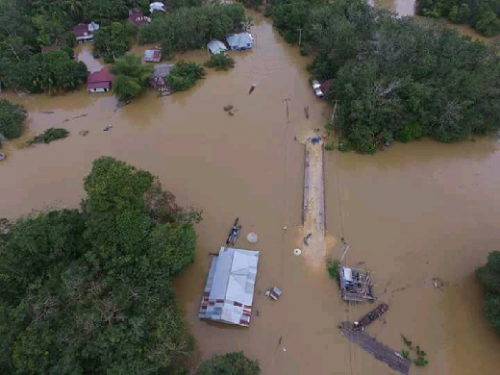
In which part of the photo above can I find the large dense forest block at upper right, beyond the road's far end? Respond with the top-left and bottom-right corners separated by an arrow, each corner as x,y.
272,0 -> 500,152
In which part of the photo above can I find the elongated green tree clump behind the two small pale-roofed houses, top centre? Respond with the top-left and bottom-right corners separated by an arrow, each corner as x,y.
139,5 -> 246,51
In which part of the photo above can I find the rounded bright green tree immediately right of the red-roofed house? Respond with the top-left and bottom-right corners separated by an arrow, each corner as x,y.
111,55 -> 153,100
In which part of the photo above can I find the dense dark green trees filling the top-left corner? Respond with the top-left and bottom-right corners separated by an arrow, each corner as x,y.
0,0 -> 149,92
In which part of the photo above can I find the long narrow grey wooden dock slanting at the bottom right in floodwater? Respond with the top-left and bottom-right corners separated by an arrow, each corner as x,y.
339,322 -> 411,375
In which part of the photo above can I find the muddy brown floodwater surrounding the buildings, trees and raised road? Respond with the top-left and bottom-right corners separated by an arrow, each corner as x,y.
0,7 -> 500,375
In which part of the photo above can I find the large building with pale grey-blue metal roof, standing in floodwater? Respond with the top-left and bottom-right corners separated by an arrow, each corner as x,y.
199,247 -> 259,327
